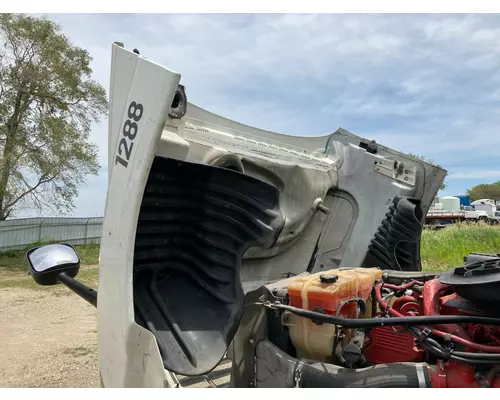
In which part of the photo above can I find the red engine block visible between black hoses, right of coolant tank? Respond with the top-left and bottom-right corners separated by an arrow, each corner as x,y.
364,279 -> 500,388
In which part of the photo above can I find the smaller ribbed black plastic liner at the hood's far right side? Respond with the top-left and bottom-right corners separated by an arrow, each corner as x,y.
363,196 -> 423,271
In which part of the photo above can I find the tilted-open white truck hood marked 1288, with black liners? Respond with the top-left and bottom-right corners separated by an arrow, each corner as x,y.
98,44 -> 445,387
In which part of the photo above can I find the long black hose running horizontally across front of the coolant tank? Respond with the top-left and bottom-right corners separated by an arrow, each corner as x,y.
264,303 -> 500,328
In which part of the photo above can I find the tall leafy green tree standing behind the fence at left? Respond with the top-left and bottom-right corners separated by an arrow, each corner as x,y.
0,14 -> 108,219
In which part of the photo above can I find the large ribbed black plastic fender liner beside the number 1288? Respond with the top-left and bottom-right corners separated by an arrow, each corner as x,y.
134,157 -> 285,376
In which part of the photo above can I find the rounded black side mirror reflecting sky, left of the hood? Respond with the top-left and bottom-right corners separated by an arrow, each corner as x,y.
26,244 -> 80,286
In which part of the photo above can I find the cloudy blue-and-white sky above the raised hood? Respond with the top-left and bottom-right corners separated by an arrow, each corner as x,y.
33,14 -> 500,217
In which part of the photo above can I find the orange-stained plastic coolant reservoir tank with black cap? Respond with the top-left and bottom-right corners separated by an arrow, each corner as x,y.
283,268 -> 382,361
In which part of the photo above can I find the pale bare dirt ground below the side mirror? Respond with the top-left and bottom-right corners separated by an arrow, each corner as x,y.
0,270 -> 230,388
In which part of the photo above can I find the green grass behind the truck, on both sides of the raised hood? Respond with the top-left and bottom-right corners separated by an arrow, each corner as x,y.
0,224 -> 500,293
